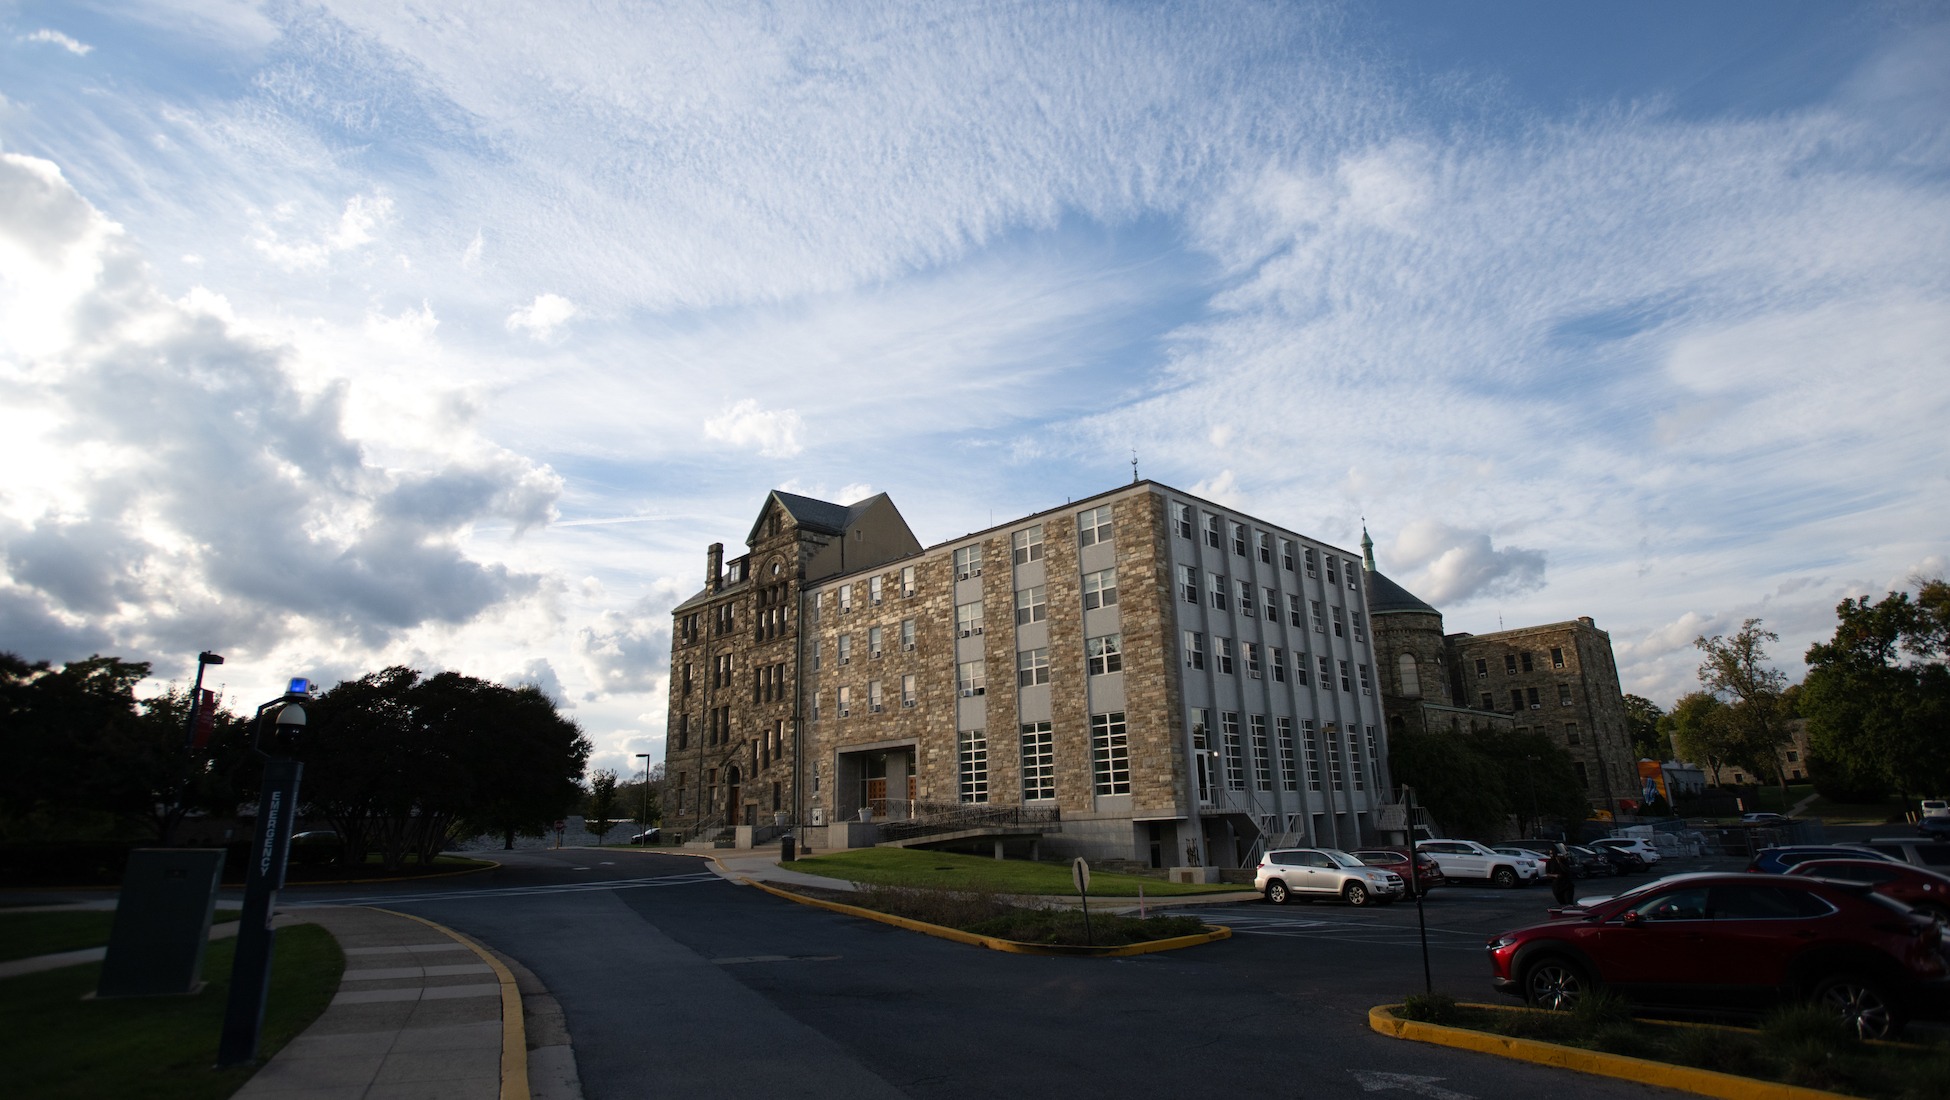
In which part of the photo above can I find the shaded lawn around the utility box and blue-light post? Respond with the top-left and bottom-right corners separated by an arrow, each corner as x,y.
0,924 -> 345,1100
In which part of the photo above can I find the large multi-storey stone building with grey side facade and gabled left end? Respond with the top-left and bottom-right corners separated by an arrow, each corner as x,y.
665,482 -> 1388,866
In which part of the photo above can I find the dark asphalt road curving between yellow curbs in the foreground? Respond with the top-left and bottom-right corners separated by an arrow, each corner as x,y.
285,850 -> 1679,1100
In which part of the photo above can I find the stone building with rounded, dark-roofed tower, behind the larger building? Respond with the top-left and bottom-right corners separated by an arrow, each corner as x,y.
1361,530 -> 1640,811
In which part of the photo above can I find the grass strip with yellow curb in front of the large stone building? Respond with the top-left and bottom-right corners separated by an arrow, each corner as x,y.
780,848 -> 1252,897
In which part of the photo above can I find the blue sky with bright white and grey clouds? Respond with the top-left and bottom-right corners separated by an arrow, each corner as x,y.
0,0 -> 1950,772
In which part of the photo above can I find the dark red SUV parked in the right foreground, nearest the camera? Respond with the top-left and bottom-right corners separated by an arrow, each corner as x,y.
1488,874 -> 1950,1038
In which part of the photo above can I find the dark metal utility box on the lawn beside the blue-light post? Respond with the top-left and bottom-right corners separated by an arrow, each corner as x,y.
96,848 -> 224,997
